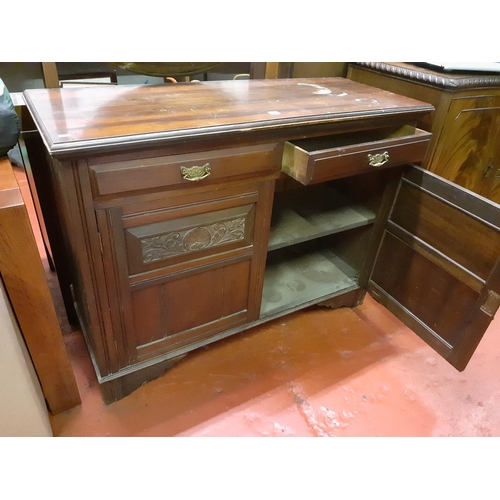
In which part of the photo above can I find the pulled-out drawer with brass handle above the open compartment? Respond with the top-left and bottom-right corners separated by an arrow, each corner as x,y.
281,126 -> 432,185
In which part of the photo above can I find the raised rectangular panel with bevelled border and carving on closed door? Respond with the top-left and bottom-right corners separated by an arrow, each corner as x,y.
125,204 -> 254,275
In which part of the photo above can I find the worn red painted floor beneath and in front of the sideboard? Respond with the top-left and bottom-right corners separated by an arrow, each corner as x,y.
11,166 -> 500,436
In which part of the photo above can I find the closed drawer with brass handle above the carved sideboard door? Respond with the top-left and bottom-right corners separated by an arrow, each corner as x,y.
89,143 -> 282,196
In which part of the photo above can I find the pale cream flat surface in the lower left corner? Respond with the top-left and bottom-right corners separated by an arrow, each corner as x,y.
0,278 -> 52,437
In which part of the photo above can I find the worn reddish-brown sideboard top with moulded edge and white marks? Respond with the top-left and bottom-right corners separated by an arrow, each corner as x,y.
24,78 -> 433,157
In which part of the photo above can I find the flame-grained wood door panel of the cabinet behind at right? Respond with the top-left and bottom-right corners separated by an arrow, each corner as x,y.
430,96 -> 500,194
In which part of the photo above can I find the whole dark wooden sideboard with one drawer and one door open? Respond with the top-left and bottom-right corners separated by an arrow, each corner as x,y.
25,78 -> 500,401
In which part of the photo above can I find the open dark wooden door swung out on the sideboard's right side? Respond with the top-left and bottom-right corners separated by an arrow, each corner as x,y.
368,167 -> 500,371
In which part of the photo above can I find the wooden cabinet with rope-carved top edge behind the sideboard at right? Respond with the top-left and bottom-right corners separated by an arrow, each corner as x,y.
348,63 -> 500,203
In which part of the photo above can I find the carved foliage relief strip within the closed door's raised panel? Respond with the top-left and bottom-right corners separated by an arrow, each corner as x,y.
140,217 -> 245,264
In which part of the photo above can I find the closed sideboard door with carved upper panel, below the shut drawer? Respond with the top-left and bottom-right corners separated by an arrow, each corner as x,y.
96,181 -> 274,366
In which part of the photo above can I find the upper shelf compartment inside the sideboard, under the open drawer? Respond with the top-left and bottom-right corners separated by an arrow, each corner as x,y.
268,184 -> 375,251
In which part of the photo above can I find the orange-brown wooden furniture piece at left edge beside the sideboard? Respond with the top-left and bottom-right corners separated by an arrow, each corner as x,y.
0,158 -> 81,415
